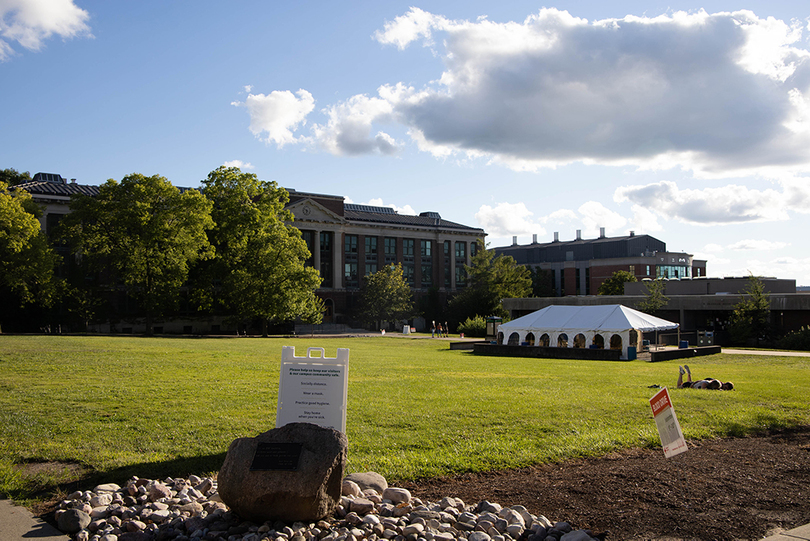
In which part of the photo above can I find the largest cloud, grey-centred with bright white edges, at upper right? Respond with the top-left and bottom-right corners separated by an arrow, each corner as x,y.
241,8 -> 810,177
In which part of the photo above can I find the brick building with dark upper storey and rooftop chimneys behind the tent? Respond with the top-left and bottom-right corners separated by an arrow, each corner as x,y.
495,228 -> 706,297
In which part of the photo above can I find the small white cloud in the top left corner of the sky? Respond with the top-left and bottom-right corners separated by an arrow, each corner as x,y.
0,0 -> 92,62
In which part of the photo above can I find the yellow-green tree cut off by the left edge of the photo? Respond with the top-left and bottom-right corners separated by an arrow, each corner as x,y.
0,182 -> 60,320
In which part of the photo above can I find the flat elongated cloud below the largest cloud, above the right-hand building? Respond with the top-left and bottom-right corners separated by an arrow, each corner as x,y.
613,181 -> 788,225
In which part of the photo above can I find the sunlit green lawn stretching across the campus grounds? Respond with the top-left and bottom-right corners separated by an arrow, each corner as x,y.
0,336 -> 810,499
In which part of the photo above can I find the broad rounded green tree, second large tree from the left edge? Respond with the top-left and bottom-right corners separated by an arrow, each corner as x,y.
60,174 -> 213,335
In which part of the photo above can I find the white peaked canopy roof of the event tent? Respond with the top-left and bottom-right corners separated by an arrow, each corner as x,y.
499,304 -> 678,335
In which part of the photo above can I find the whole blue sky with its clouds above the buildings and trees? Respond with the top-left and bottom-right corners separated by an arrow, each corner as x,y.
0,0 -> 810,285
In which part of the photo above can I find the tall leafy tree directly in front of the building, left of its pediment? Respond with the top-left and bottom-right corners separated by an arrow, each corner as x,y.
202,167 -> 323,336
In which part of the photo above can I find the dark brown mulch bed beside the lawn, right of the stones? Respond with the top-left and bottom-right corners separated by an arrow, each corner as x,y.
404,427 -> 810,540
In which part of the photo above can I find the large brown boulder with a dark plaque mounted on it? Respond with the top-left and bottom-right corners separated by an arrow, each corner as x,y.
217,423 -> 346,523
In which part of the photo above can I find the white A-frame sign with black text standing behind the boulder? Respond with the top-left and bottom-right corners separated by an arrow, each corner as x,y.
276,346 -> 349,434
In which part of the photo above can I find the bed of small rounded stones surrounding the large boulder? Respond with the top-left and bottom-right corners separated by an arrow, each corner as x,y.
57,470 -> 596,541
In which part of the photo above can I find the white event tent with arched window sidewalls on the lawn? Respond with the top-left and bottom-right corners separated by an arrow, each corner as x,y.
498,304 -> 678,359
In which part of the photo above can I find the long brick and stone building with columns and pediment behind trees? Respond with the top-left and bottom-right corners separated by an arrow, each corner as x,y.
14,173 -> 486,330
